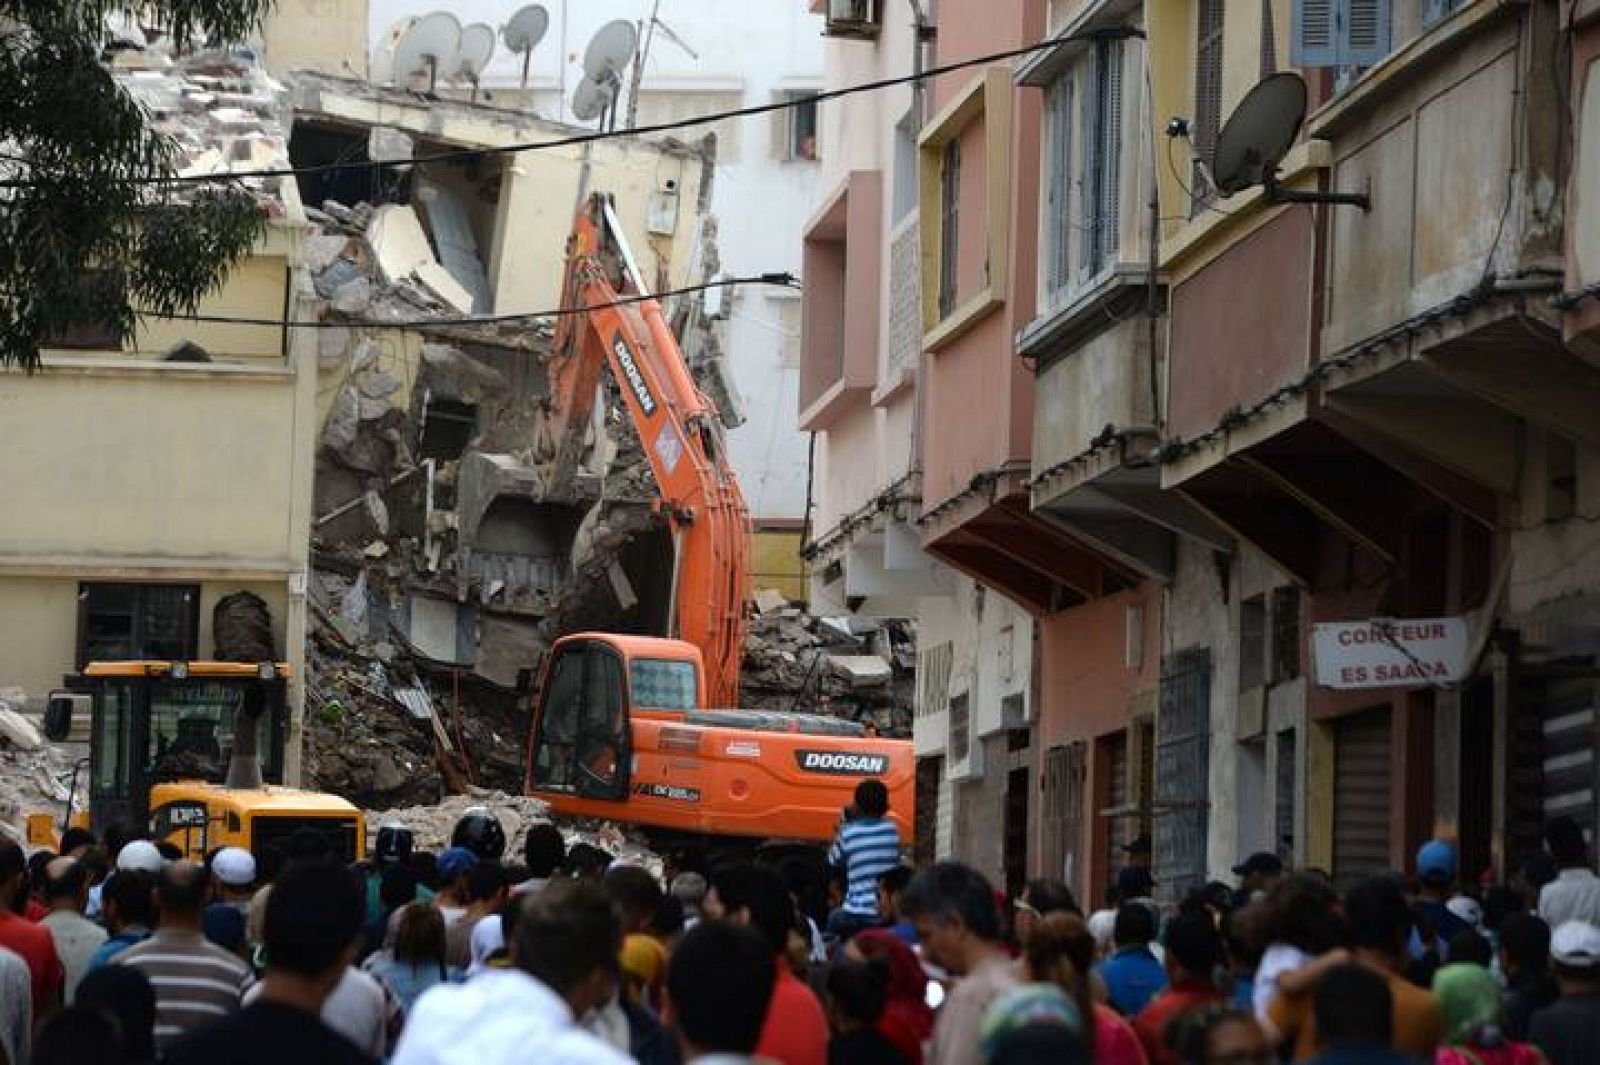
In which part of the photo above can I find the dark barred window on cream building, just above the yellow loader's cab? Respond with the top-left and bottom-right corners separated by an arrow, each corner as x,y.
77,582 -> 200,668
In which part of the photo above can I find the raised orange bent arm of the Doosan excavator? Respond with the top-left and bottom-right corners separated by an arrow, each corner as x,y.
544,193 -> 750,707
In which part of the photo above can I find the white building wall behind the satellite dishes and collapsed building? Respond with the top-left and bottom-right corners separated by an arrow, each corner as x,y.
366,0 -> 824,525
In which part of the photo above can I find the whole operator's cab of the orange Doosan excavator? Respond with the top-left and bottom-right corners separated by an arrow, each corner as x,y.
528,633 -> 701,801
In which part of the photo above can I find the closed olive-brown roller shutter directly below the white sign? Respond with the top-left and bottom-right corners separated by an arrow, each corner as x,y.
1333,708 -> 1394,889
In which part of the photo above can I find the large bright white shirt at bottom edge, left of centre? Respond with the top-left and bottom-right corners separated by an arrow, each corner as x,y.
390,969 -> 634,1065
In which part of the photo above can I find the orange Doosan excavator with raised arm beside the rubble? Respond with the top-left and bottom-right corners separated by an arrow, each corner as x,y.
525,193 -> 915,841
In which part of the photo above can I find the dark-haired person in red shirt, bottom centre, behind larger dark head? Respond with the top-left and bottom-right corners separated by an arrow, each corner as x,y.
707,865 -> 827,1065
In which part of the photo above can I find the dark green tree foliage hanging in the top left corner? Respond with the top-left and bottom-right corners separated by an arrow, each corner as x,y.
0,0 -> 270,369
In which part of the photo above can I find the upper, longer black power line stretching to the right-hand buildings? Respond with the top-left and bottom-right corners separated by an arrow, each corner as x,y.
0,27 -> 1144,189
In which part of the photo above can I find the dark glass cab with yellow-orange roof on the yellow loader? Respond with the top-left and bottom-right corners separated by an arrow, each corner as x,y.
67,662 -> 288,838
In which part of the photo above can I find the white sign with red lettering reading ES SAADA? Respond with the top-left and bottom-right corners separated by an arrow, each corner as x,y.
1312,617 -> 1470,688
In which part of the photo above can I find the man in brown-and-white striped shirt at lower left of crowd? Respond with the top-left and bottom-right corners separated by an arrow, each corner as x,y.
112,862 -> 251,1054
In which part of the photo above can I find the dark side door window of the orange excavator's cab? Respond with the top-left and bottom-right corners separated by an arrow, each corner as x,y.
533,643 -> 632,800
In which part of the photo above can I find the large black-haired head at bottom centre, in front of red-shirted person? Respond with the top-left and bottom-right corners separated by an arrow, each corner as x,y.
667,921 -> 778,1055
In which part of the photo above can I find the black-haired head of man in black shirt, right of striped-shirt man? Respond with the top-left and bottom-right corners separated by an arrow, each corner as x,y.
262,862 -> 366,979
